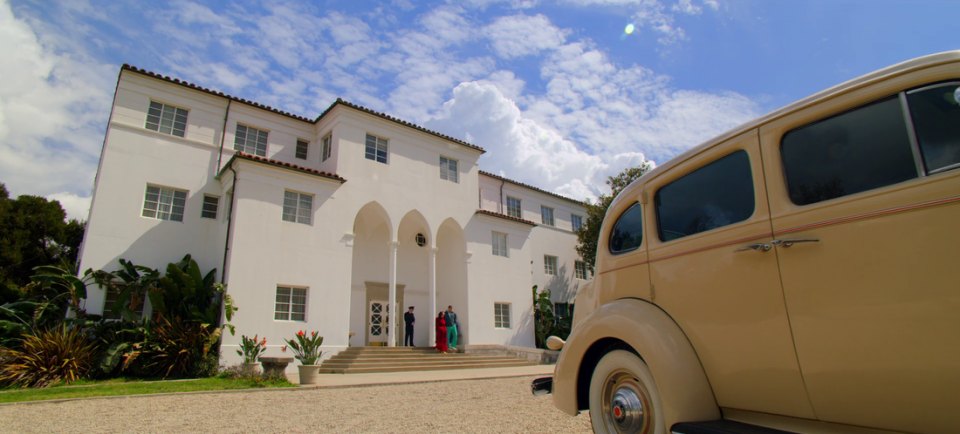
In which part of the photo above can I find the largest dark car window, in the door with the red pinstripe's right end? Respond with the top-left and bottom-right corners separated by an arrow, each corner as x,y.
780,97 -> 917,205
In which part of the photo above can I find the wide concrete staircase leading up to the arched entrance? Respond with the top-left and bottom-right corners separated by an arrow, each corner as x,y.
320,347 -> 536,374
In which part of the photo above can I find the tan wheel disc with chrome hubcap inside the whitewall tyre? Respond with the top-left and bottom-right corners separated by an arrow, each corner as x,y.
603,372 -> 651,433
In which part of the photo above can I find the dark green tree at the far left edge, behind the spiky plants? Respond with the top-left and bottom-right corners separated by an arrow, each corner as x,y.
0,183 -> 84,304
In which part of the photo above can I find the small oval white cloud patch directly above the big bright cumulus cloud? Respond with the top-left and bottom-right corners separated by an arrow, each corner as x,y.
483,15 -> 568,59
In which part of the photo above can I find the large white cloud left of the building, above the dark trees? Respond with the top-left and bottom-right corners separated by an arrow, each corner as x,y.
0,2 -> 116,218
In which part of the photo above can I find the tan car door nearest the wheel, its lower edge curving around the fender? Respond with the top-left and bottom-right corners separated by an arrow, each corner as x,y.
645,130 -> 813,418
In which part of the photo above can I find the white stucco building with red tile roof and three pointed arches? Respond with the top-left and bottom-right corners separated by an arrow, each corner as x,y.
80,65 -> 588,364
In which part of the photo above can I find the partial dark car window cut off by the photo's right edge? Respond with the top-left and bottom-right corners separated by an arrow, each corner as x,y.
907,82 -> 960,173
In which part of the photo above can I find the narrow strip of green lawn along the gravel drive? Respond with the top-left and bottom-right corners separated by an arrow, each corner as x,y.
0,377 -> 296,403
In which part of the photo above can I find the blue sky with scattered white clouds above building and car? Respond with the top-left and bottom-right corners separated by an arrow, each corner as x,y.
0,0 -> 960,220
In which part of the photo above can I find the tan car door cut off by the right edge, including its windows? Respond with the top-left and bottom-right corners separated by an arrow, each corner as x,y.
760,73 -> 960,432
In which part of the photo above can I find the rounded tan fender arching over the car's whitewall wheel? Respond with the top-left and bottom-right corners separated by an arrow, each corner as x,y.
553,299 -> 720,428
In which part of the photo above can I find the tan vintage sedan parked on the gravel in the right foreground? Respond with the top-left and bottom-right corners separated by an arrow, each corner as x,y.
535,51 -> 960,433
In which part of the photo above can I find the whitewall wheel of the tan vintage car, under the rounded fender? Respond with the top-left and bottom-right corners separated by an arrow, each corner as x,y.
590,350 -> 666,434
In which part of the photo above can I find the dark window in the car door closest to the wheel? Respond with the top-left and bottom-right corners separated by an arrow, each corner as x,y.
654,150 -> 755,241
